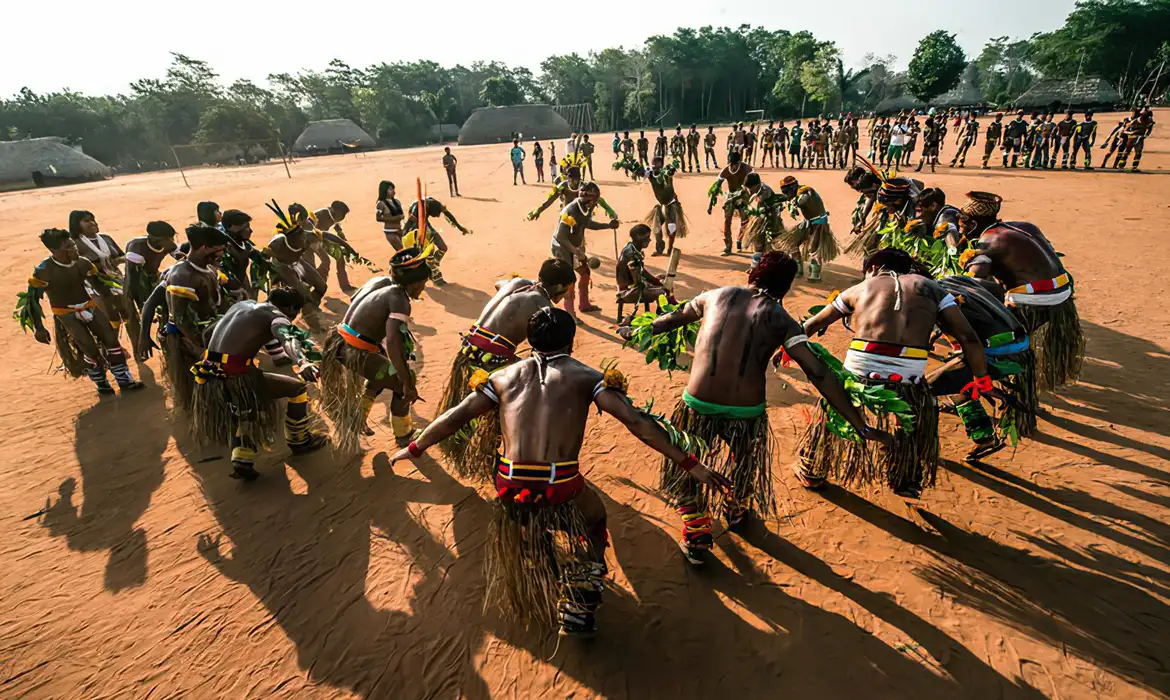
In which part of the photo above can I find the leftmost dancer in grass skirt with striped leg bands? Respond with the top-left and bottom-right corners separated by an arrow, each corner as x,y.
14,228 -> 143,394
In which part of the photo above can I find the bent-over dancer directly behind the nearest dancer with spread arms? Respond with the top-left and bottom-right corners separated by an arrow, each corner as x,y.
439,258 -> 577,480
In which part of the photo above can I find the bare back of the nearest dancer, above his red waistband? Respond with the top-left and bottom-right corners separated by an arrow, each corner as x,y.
491,355 -> 601,462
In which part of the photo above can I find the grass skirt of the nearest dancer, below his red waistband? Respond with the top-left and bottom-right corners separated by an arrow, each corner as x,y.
484,500 -> 600,625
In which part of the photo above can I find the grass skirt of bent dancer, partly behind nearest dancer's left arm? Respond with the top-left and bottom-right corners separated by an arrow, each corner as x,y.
439,348 -> 500,482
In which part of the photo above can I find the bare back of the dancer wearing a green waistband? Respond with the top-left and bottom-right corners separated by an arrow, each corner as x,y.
687,287 -> 803,406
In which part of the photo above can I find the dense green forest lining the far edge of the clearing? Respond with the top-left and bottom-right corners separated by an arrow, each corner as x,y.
0,0 -> 1170,170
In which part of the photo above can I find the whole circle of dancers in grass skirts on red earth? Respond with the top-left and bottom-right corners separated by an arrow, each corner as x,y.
16,136 -> 1083,634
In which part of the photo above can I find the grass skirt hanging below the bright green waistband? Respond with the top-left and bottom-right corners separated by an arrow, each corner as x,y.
659,398 -> 776,517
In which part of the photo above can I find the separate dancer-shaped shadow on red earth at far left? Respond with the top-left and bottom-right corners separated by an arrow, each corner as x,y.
41,364 -> 170,592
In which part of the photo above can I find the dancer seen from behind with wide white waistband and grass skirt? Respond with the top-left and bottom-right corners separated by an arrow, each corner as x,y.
796,248 -> 992,499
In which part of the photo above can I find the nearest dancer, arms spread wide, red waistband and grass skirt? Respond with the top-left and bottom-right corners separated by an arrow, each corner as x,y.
391,308 -> 727,636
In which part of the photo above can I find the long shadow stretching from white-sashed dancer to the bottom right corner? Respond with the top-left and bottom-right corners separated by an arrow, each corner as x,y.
824,488 -> 1170,693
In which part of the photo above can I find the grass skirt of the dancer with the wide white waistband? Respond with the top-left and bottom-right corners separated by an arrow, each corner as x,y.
798,377 -> 938,489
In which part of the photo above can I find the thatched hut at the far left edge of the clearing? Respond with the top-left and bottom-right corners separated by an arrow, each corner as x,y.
0,137 -> 113,190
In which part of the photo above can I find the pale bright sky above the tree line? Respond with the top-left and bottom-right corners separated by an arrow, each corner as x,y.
0,0 -> 1074,97
